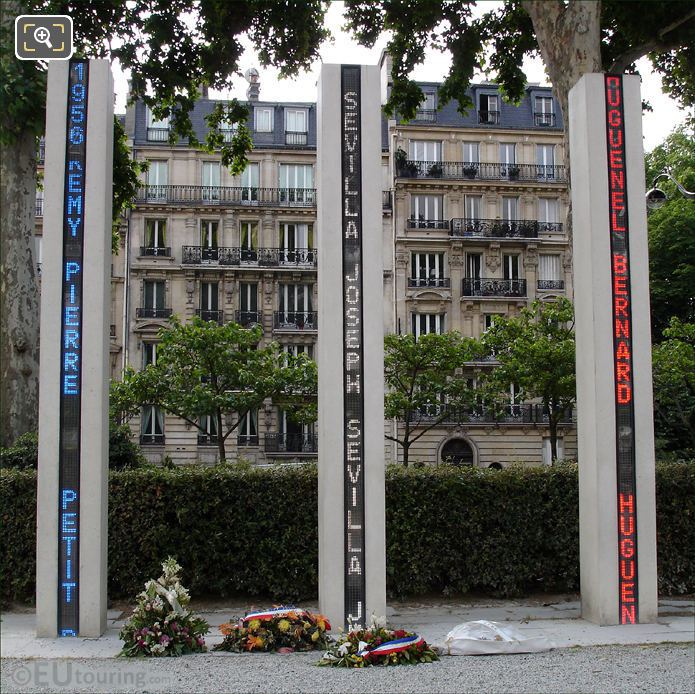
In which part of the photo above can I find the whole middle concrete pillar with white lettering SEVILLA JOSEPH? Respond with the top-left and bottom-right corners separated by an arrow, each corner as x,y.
317,65 -> 386,628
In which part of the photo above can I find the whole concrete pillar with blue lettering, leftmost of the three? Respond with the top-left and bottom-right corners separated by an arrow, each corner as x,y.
36,60 -> 113,637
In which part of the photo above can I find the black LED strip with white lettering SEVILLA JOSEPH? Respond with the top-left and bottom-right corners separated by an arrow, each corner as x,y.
340,65 -> 365,626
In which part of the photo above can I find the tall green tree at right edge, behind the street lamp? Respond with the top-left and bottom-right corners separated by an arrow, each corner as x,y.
646,127 -> 695,343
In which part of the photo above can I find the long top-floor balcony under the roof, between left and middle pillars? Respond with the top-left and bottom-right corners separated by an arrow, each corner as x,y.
135,185 -> 316,207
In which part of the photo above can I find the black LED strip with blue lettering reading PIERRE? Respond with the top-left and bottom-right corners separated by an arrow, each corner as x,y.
58,60 -> 89,636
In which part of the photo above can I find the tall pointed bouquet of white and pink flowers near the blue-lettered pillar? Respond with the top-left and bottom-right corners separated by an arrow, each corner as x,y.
120,557 -> 210,657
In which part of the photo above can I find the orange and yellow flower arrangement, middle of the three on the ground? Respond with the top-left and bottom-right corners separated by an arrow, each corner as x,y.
214,606 -> 331,653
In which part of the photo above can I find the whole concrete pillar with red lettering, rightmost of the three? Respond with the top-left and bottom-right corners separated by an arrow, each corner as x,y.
569,74 -> 657,624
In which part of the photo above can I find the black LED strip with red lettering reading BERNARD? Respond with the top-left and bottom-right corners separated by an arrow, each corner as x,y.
605,75 -> 639,624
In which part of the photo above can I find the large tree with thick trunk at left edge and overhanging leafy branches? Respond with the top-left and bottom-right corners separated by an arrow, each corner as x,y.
0,0 -> 329,444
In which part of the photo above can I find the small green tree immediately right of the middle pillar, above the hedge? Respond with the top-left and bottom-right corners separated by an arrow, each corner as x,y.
384,332 -> 476,467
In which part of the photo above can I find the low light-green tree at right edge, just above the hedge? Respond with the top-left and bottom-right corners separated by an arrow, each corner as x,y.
652,318 -> 695,458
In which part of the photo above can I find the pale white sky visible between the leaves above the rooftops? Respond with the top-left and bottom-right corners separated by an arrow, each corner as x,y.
114,2 -> 686,151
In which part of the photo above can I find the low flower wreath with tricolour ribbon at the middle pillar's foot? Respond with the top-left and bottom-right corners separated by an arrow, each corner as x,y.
318,617 -> 439,667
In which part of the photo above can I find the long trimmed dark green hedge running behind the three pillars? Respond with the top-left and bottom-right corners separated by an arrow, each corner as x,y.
0,463 -> 695,601
